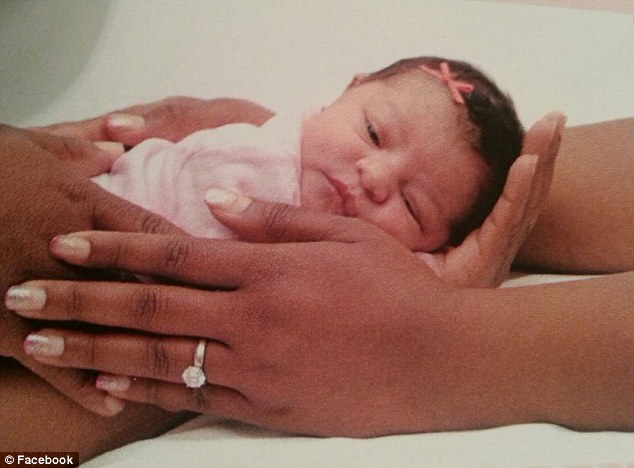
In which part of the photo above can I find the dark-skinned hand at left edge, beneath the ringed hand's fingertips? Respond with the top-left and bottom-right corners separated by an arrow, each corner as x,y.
0,126 -> 179,414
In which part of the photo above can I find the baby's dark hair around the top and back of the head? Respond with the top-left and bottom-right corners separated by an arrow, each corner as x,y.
363,57 -> 524,245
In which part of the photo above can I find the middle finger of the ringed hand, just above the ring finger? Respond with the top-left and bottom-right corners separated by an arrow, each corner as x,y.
5,281 -> 240,342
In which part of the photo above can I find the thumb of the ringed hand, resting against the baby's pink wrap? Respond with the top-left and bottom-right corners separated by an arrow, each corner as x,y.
205,188 -> 378,242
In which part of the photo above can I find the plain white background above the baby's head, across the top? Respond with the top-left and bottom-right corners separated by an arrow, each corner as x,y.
0,0 -> 634,129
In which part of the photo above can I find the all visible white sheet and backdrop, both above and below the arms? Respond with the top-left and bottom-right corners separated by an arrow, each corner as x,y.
0,0 -> 634,468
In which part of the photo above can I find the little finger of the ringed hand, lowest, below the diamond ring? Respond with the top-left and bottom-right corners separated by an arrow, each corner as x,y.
103,376 -> 252,422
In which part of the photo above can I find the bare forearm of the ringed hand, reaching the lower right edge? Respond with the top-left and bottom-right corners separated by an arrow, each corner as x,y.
454,273 -> 634,430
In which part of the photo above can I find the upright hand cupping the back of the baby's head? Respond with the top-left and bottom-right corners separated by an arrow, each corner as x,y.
418,112 -> 565,287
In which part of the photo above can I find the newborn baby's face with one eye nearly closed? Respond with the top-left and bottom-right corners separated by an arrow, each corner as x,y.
301,70 -> 487,252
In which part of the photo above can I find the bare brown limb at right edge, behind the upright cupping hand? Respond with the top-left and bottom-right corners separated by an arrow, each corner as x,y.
517,118 -> 634,273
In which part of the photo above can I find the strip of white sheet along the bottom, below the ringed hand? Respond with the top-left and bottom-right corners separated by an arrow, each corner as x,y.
83,421 -> 634,468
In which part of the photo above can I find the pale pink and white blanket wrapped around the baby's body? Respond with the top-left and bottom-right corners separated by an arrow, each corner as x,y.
92,115 -> 300,239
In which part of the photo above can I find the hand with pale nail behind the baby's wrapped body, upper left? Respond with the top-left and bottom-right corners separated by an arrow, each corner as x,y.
41,96 -> 274,146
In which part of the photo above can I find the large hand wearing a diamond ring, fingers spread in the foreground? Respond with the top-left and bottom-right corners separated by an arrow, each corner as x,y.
3,196 -> 460,435
